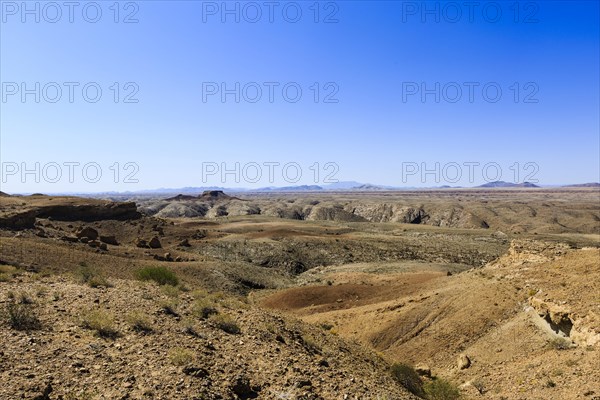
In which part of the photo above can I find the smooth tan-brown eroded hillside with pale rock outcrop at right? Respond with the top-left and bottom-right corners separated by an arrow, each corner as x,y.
261,240 -> 600,399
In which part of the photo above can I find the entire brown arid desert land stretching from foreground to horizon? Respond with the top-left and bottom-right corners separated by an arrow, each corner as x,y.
0,188 -> 600,400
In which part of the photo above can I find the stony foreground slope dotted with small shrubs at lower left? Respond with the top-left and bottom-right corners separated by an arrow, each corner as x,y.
0,274 -> 412,399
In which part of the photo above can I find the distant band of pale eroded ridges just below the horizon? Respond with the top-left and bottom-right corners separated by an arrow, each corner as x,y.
140,188 -> 600,234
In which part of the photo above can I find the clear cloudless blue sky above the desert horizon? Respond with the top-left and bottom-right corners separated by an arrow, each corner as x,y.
0,1 -> 600,192
